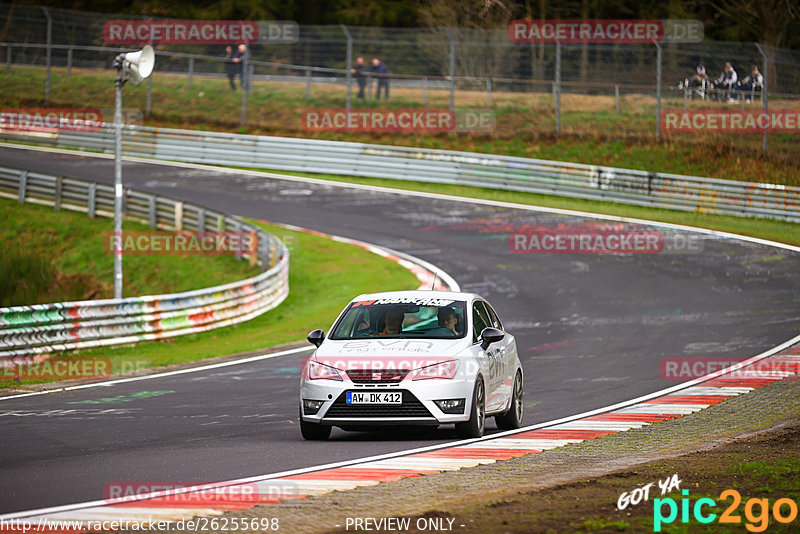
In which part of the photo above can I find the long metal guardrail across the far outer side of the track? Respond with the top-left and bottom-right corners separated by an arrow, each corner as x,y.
0,125 -> 800,222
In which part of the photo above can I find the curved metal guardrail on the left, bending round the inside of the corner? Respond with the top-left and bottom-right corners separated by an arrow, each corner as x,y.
0,167 -> 289,365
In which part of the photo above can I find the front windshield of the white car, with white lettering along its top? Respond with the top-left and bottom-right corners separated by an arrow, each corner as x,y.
330,297 -> 467,340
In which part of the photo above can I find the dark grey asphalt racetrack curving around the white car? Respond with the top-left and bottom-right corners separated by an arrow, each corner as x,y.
0,148 -> 800,513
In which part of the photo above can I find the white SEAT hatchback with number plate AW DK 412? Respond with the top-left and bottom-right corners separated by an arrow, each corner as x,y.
300,291 -> 523,440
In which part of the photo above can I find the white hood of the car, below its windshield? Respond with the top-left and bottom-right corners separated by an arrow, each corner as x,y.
313,338 -> 471,369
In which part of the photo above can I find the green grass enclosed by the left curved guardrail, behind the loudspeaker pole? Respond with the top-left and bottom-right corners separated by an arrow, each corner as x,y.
0,198 -> 258,306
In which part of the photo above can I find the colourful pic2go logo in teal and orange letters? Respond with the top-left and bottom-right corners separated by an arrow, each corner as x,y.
653,489 -> 797,532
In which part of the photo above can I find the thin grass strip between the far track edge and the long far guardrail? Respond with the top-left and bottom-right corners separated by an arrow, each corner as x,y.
248,169 -> 800,245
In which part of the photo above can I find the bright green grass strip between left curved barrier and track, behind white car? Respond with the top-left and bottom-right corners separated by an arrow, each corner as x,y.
0,221 -> 419,387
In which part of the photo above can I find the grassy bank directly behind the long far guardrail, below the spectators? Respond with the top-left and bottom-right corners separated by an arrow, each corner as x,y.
0,66 -> 800,185
